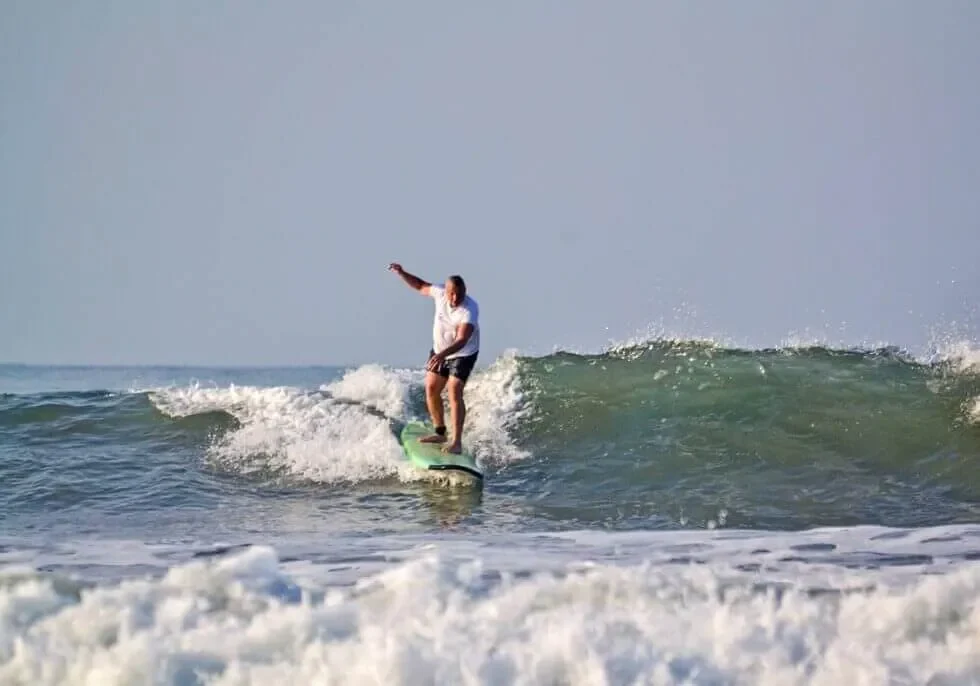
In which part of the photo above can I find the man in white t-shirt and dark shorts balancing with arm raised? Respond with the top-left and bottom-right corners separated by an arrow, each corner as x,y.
388,262 -> 480,453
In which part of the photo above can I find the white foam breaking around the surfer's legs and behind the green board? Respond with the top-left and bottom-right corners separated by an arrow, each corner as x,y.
150,356 -> 527,483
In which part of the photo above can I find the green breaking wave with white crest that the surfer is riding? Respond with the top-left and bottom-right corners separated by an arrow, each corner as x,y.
0,339 -> 980,527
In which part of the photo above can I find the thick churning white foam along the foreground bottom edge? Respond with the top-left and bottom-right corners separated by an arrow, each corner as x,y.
0,547 -> 980,686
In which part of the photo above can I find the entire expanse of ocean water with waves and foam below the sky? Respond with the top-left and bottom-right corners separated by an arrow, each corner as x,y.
0,340 -> 980,686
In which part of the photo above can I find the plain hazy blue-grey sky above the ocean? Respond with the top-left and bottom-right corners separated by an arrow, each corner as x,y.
0,0 -> 980,365
